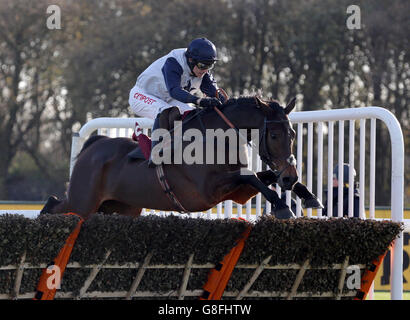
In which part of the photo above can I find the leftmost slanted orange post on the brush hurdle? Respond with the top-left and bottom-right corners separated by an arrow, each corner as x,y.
33,212 -> 84,300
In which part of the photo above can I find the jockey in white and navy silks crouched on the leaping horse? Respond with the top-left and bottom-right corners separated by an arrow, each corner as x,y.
129,38 -> 224,166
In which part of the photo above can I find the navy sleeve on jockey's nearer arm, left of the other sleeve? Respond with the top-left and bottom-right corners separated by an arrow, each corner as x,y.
162,58 -> 198,103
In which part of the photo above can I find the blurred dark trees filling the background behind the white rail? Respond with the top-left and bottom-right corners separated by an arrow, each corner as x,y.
0,0 -> 410,206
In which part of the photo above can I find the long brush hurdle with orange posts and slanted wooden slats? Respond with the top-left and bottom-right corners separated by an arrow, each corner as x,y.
0,214 -> 401,300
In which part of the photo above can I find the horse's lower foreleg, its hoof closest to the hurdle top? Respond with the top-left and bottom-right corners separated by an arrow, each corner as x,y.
239,170 -> 296,219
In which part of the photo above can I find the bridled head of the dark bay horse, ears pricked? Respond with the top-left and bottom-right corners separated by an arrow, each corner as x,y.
256,98 -> 298,190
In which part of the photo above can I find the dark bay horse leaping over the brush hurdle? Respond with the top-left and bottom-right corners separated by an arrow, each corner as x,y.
41,96 -> 310,219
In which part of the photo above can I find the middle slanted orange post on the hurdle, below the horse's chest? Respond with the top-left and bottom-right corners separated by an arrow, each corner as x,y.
199,222 -> 251,300
